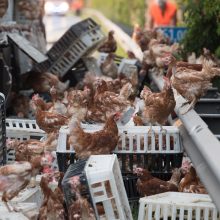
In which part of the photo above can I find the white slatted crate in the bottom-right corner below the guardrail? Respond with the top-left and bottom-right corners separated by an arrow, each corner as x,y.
138,192 -> 220,220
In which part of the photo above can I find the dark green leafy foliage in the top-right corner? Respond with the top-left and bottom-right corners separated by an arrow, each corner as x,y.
181,0 -> 220,57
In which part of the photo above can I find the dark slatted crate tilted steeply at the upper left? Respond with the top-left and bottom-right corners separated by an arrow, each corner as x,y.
35,18 -> 105,77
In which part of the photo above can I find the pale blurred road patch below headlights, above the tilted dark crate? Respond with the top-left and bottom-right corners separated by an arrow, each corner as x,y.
44,14 -> 81,49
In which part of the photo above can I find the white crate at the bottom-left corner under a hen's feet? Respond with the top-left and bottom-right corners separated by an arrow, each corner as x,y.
0,202 -> 38,220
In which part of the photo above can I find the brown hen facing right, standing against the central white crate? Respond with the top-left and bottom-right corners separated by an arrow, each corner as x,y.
69,114 -> 119,158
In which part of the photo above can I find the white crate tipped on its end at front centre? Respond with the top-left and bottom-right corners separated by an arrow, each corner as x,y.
84,155 -> 132,220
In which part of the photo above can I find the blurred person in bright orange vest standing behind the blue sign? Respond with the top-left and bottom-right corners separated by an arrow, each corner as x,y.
149,0 -> 177,28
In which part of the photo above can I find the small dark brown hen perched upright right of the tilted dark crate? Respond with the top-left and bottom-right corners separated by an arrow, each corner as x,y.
98,31 -> 117,53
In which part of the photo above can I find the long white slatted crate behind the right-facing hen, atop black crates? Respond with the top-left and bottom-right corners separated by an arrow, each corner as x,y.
57,124 -> 183,153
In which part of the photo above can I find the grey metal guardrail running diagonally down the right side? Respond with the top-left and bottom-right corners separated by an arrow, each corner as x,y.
85,10 -> 220,211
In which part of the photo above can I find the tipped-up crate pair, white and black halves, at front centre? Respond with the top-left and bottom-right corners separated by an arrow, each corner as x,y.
62,155 -> 132,220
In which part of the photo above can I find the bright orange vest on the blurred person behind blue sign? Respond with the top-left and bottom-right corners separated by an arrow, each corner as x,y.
150,1 -> 177,26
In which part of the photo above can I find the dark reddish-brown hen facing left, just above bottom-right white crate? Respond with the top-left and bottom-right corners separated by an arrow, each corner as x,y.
134,167 -> 178,196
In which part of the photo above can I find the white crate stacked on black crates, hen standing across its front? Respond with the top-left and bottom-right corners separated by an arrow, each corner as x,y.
57,124 -> 183,206
